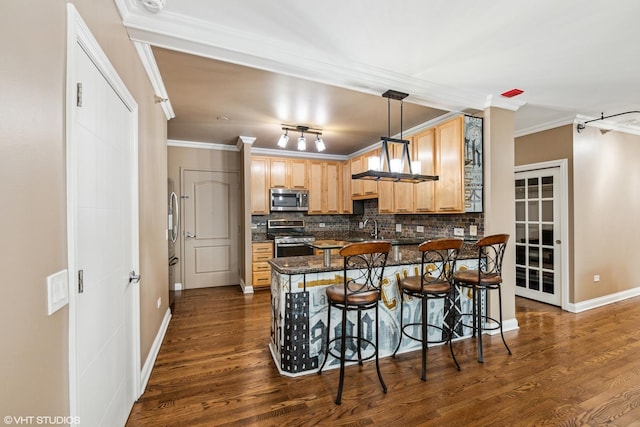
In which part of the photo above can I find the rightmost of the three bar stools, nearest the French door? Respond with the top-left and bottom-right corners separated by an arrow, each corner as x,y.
453,234 -> 511,363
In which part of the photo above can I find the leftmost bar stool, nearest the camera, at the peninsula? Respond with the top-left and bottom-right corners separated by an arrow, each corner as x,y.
318,241 -> 391,405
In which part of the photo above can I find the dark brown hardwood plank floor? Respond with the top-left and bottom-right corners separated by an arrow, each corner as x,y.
127,287 -> 640,427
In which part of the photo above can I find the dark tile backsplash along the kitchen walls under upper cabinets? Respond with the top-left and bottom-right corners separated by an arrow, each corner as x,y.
251,199 -> 484,240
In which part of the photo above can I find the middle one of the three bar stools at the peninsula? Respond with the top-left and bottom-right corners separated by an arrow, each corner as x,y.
393,239 -> 463,381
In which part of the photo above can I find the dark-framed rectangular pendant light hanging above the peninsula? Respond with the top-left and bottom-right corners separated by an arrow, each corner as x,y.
351,90 -> 438,184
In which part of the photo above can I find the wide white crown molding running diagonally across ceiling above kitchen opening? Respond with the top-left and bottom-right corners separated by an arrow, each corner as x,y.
116,5 -> 490,111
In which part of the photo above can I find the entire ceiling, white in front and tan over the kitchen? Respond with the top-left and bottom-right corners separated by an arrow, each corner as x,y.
115,0 -> 640,156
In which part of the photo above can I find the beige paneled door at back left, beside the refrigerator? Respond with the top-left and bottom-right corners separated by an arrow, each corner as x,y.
182,170 -> 240,289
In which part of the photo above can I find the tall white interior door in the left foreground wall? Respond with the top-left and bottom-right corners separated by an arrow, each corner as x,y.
67,5 -> 140,426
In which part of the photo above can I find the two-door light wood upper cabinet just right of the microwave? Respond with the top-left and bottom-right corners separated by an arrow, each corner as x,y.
307,160 -> 342,214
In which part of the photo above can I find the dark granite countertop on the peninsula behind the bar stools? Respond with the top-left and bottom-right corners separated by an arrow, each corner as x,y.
269,239 -> 477,275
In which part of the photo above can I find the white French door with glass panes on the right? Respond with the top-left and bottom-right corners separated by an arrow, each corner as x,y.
515,167 -> 563,306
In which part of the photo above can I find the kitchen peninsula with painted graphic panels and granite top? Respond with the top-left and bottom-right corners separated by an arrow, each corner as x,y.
269,241 -> 475,376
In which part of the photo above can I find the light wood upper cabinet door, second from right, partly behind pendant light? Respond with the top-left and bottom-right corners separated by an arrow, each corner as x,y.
413,129 -> 436,213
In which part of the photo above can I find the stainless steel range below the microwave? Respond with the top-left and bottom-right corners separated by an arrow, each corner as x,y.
267,219 -> 316,258
